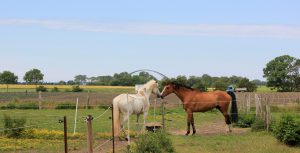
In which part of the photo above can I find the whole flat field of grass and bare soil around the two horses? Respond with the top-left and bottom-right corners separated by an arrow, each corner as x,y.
0,86 -> 300,153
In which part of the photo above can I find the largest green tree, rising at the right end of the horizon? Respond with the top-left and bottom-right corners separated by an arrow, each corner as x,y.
263,55 -> 300,92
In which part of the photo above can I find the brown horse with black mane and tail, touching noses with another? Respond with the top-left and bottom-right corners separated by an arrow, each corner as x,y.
161,83 -> 237,135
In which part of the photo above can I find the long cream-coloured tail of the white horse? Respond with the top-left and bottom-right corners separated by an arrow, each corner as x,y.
113,98 -> 121,137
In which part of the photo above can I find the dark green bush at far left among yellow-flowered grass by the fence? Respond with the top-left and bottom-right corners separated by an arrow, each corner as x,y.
3,114 -> 26,138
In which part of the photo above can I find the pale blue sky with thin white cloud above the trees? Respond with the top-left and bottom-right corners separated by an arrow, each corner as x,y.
0,0 -> 300,81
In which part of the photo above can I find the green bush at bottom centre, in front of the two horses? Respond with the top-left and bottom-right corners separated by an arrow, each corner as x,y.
133,131 -> 175,153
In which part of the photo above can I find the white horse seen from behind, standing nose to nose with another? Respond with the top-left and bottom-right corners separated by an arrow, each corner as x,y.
113,80 -> 161,139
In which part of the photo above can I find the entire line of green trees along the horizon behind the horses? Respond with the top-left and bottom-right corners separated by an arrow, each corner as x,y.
0,55 -> 300,92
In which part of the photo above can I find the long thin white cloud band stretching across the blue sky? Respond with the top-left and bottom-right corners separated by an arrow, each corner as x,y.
0,19 -> 300,38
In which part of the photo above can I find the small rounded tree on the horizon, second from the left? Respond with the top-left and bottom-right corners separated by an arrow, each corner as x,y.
23,69 -> 44,85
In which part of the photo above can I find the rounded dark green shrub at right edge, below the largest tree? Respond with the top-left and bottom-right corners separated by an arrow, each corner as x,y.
274,114 -> 300,146
